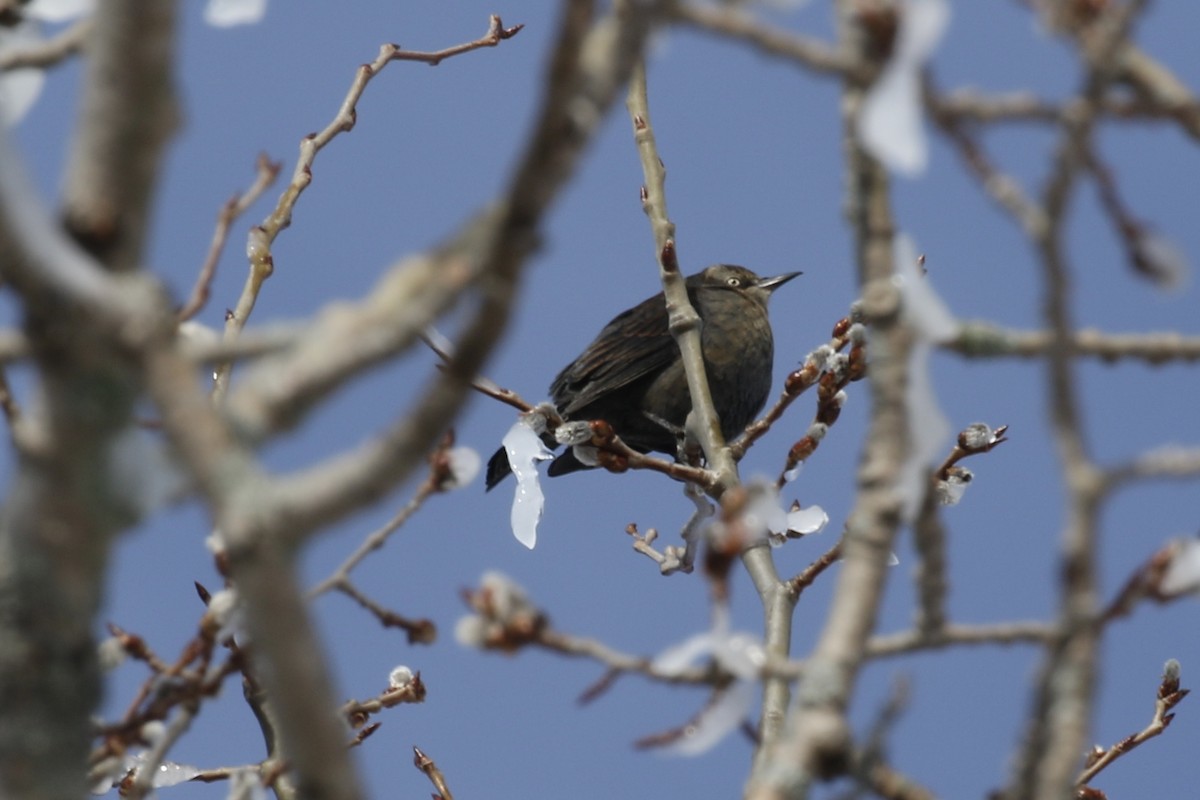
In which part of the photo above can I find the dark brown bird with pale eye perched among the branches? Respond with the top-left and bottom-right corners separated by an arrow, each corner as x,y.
485,264 -> 800,491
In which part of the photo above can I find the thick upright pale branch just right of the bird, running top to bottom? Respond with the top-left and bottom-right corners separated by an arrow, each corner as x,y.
746,2 -> 911,800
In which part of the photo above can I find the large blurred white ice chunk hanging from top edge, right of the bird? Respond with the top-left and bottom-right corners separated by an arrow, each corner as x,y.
858,0 -> 950,176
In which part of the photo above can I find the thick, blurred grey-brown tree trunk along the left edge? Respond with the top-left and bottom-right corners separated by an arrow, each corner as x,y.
0,0 -> 174,798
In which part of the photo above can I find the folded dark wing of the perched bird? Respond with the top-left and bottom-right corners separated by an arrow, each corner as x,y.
550,294 -> 679,416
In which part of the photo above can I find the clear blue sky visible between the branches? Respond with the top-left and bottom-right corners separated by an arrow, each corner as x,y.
9,0 -> 1200,800
